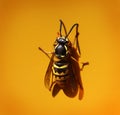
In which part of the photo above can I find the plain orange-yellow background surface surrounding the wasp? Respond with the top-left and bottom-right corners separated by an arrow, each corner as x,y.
0,0 -> 120,115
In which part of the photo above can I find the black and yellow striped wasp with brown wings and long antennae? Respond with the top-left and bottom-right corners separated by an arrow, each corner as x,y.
39,20 -> 89,100
